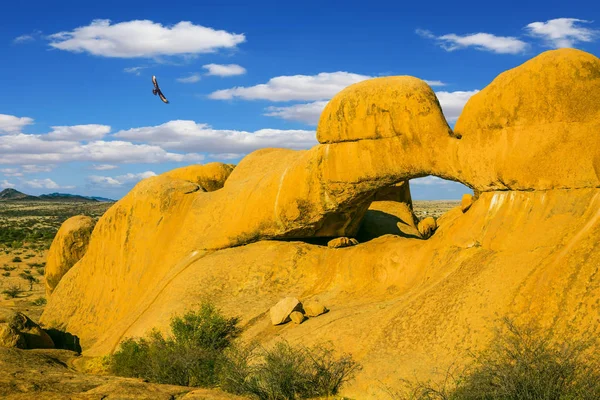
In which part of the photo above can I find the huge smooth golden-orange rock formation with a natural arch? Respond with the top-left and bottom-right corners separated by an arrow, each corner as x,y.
41,49 -> 600,399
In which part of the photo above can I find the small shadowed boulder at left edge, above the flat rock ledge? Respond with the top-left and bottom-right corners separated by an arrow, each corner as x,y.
0,308 -> 54,349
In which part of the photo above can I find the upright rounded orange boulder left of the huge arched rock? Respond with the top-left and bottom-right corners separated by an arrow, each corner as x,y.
44,215 -> 95,296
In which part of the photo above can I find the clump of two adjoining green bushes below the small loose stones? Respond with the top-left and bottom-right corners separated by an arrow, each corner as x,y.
108,303 -> 359,400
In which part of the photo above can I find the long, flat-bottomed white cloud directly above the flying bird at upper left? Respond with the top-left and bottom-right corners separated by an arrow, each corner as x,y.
48,19 -> 246,58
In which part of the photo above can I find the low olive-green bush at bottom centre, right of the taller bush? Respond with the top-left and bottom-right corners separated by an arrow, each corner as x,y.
219,342 -> 360,400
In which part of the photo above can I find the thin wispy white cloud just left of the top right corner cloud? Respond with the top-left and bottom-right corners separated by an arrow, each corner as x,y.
416,29 -> 528,54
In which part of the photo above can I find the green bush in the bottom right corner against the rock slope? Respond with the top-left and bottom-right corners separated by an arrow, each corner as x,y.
399,318 -> 600,400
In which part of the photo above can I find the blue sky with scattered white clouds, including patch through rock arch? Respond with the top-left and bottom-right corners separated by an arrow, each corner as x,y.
0,0 -> 600,199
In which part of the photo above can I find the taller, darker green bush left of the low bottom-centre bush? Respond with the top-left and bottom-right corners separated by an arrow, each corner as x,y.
110,303 -> 241,387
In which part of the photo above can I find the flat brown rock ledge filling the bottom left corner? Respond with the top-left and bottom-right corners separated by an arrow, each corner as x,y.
0,348 -> 243,400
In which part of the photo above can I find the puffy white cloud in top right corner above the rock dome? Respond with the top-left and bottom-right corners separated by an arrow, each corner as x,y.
525,18 -> 600,48
